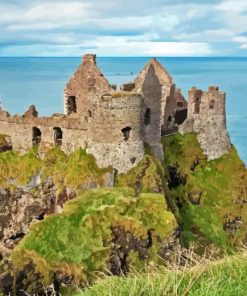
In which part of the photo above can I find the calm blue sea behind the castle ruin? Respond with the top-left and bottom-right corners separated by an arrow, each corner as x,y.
0,58 -> 247,163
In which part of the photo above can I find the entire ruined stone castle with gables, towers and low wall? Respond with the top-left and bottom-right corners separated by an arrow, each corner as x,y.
0,54 -> 230,173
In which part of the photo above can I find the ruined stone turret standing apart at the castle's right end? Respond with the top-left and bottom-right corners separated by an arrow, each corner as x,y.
179,86 -> 231,160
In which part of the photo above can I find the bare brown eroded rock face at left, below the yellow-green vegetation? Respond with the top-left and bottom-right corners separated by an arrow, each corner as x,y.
0,173 -> 114,256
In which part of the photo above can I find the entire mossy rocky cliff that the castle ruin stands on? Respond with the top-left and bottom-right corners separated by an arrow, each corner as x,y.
0,133 -> 247,294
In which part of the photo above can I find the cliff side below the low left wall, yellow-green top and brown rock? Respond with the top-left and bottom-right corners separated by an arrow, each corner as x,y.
0,148 -> 114,255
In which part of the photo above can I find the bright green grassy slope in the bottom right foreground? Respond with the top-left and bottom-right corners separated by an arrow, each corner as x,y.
79,255 -> 247,296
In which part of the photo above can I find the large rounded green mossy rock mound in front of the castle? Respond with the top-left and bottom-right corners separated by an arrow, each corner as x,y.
0,188 -> 177,293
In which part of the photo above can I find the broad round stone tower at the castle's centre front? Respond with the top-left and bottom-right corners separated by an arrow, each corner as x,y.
87,93 -> 144,173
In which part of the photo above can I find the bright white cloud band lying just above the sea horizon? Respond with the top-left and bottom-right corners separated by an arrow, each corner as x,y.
0,37 -> 213,56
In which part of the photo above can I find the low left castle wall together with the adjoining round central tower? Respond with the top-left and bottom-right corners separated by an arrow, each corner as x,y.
0,92 -> 145,173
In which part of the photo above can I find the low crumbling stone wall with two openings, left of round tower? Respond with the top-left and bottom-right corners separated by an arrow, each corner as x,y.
0,107 -> 88,152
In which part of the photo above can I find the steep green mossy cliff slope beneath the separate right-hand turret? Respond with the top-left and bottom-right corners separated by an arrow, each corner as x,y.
163,134 -> 247,249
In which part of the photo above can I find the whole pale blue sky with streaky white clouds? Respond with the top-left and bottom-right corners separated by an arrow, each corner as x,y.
0,0 -> 247,56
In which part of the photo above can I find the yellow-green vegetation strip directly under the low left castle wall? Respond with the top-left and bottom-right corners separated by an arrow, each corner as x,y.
0,147 -> 112,193
